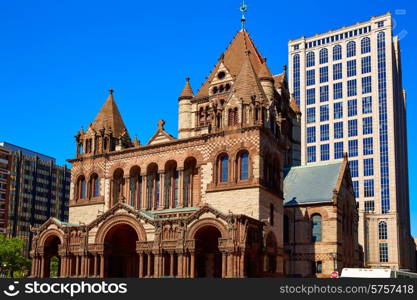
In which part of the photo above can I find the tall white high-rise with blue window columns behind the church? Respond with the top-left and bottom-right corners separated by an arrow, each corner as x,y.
288,13 -> 415,269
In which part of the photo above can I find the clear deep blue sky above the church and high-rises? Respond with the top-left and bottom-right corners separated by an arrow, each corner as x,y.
0,0 -> 417,235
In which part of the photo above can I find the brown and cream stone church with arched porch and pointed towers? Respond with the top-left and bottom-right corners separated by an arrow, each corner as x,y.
31,29 -> 357,278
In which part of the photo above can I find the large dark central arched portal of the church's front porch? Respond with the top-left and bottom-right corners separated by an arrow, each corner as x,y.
104,224 -> 139,277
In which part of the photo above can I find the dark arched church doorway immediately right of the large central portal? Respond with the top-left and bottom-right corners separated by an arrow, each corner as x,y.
194,226 -> 222,278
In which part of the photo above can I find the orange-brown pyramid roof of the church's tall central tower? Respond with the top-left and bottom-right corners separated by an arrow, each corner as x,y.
196,30 -> 264,97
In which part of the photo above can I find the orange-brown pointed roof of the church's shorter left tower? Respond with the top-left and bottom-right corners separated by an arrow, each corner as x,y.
91,90 -> 127,137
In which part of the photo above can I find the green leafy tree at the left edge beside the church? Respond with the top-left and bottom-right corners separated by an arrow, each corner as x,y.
0,235 -> 31,278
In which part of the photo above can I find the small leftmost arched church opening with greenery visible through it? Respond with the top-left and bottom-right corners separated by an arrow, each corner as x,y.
42,235 -> 61,278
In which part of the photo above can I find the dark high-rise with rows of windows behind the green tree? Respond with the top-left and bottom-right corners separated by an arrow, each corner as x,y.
0,142 -> 71,254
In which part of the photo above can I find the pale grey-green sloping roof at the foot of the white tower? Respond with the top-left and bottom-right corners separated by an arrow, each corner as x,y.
284,162 -> 344,206
